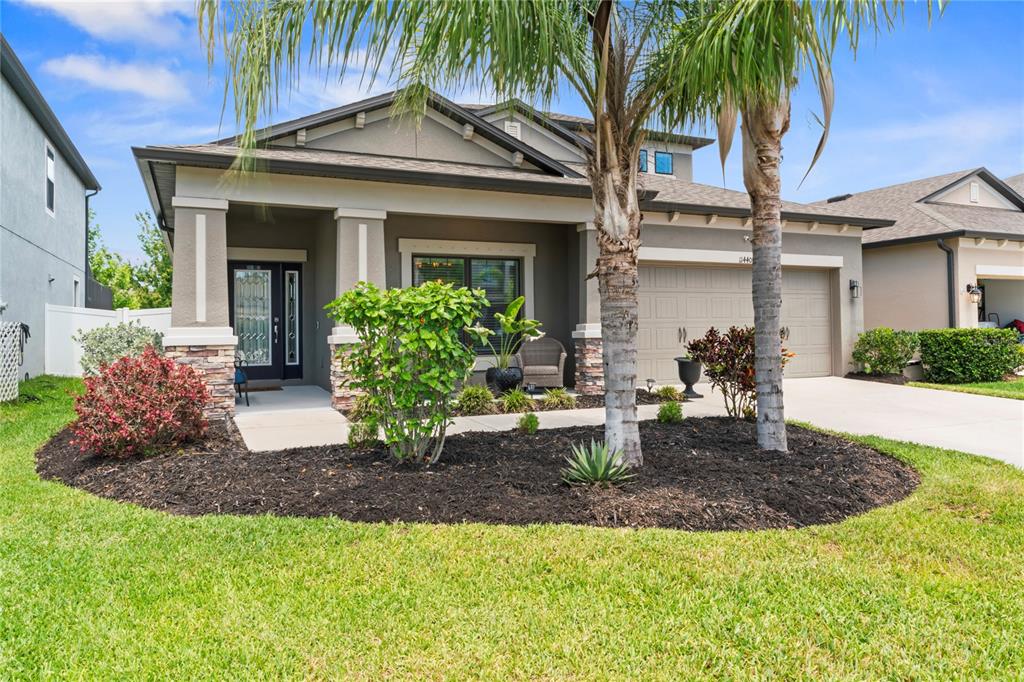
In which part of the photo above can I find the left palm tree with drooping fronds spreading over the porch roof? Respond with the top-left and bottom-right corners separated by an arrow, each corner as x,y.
199,0 -> 704,466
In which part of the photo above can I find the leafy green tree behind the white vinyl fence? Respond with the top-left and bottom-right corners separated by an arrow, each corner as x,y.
88,212 -> 172,309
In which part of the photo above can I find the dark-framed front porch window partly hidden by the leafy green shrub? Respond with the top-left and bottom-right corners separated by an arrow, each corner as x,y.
413,256 -> 522,351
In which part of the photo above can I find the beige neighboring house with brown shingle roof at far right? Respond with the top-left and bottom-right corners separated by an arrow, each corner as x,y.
819,168 -> 1024,330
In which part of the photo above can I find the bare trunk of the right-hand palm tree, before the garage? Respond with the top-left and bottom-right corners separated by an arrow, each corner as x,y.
742,96 -> 790,452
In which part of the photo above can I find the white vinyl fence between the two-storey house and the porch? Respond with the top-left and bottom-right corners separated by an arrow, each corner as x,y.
44,303 -> 171,377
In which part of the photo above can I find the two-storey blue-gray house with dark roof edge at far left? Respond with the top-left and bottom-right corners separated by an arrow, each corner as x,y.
0,36 -> 103,375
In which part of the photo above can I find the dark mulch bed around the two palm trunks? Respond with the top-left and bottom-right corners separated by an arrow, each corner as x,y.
37,418 -> 919,530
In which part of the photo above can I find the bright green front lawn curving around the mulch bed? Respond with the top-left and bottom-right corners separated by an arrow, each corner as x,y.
0,378 -> 1024,680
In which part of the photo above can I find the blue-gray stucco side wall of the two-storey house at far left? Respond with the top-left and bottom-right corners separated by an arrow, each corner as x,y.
0,74 -> 85,375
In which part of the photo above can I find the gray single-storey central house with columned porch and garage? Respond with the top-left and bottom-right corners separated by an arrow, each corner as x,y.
133,87 -> 891,411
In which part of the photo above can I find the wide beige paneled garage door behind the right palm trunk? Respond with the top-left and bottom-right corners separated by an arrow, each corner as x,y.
637,264 -> 831,385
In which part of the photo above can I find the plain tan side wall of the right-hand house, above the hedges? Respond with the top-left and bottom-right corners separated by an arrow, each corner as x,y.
863,242 -> 949,331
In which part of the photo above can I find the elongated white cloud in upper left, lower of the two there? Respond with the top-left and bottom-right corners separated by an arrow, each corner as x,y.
43,54 -> 189,101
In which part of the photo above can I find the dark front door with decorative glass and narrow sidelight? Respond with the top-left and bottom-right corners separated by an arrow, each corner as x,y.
227,261 -> 302,379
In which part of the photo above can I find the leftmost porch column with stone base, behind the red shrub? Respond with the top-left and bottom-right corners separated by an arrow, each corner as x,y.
164,197 -> 239,424
